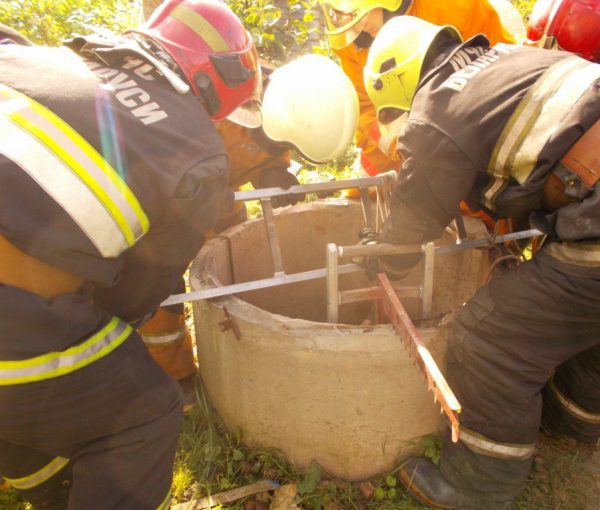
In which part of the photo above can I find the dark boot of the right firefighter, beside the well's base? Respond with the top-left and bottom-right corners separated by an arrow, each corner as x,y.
398,457 -> 512,510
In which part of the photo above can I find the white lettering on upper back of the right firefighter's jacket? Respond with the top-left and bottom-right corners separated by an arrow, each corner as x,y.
442,43 -> 518,92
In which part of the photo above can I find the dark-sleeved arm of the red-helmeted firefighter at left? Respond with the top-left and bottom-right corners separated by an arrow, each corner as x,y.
94,156 -> 230,322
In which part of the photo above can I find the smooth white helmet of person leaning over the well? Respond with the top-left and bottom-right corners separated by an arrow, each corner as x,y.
261,55 -> 358,163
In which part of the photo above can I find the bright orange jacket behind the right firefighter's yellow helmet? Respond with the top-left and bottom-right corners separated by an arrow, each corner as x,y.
334,0 -> 516,175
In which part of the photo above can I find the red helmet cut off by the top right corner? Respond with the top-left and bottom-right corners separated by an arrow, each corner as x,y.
527,0 -> 600,62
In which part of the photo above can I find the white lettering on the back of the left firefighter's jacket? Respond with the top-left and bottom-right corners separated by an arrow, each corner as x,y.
85,57 -> 168,125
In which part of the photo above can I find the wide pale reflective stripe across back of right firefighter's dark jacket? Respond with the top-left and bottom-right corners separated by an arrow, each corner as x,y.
484,57 -> 600,209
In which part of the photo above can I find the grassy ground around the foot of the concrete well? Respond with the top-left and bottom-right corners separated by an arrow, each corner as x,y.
165,378 -> 600,510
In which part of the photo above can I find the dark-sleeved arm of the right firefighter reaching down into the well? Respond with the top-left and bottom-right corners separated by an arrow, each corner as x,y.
379,124 -> 476,279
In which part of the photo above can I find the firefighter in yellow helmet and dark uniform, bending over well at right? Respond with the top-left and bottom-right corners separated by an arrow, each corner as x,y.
365,16 -> 600,510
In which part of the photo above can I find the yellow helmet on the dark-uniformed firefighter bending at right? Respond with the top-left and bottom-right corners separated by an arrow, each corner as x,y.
364,16 -> 462,119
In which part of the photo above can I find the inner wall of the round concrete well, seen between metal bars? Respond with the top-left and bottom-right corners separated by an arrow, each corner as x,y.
202,201 -> 485,325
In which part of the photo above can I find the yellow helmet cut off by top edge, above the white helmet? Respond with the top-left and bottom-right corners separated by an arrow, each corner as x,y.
319,0 -> 402,49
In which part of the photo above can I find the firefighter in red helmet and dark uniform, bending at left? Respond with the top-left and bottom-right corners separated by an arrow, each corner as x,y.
0,0 -> 261,510
